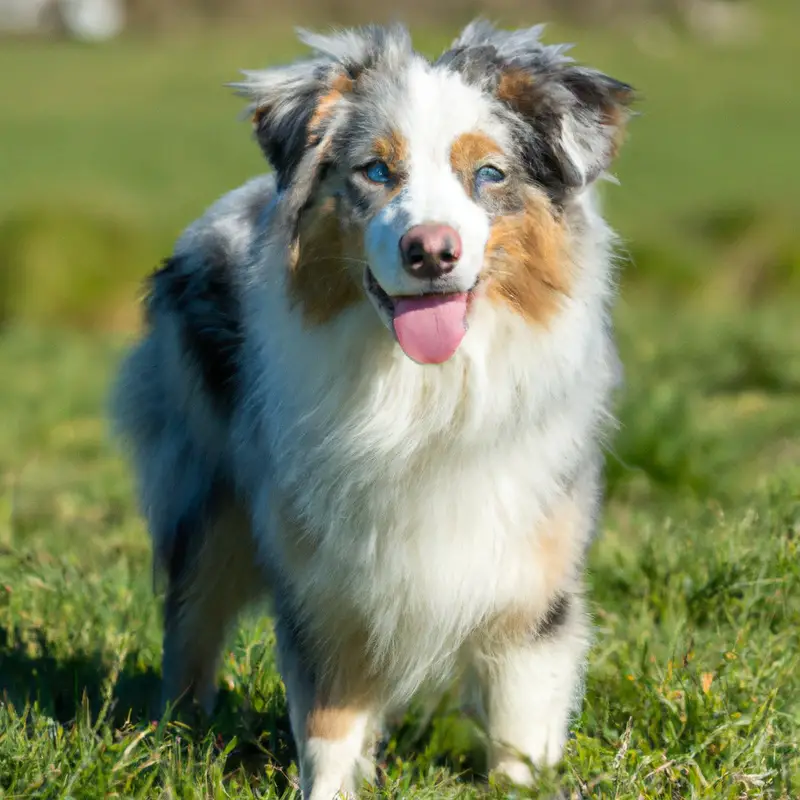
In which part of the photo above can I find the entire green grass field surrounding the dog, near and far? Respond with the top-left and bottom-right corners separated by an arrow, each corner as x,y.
0,0 -> 800,800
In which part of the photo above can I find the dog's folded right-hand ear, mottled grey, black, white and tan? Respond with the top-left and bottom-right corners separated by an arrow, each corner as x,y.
440,20 -> 636,194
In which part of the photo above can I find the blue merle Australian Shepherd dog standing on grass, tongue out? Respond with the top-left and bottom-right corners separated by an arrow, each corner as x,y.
113,20 -> 635,800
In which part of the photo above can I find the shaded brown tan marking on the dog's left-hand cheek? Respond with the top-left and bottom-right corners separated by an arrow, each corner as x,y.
289,200 -> 364,325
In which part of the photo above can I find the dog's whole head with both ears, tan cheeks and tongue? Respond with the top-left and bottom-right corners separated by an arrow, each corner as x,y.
238,23 -> 632,363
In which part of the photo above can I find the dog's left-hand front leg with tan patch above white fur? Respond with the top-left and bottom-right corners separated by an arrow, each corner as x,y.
277,620 -> 378,800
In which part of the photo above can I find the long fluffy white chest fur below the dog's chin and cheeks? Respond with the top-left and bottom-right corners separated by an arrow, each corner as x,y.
234,270 -> 610,694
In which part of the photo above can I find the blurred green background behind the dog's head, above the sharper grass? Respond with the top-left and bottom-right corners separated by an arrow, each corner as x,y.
0,0 -> 800,330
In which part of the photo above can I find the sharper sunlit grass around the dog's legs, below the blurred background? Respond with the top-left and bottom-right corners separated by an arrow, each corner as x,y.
0,296 -> 800,800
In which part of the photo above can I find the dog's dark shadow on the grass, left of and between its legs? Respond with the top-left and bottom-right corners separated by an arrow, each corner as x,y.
0,629 -> 486,796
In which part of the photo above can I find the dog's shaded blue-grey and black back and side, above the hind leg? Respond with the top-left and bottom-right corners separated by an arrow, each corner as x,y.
112,176 -> 274,569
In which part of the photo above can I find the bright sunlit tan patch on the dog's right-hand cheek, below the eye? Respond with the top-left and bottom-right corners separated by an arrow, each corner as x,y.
486,193 -> 572,325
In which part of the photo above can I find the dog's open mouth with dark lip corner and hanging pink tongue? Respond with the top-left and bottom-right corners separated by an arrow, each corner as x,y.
364,267 -> 474,364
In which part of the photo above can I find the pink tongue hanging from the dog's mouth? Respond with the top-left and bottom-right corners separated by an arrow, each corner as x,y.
394,293 -> 467,364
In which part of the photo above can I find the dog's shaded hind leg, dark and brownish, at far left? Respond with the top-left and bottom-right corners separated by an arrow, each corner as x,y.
162,501 -> 266,714
